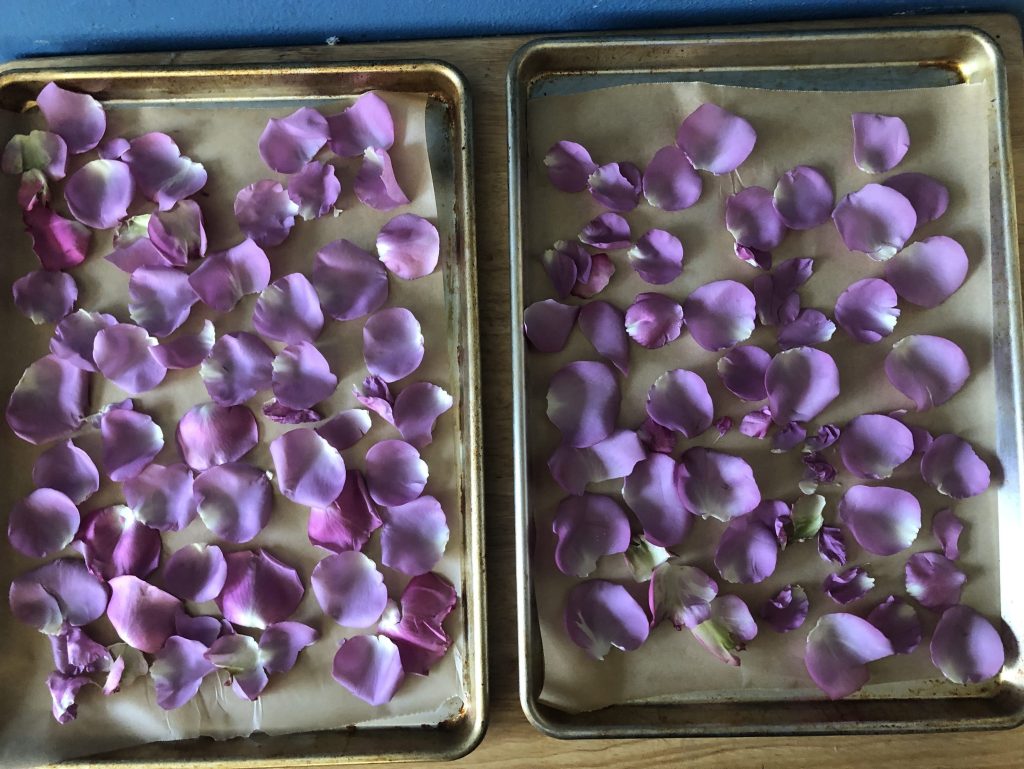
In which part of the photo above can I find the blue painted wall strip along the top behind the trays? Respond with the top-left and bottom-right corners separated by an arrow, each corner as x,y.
0,0 -> 1024,60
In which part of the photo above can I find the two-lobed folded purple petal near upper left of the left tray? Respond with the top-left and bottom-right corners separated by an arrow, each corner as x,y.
123,132 -> 207,211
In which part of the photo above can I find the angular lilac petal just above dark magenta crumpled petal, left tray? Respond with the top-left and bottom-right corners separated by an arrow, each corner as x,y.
270,427 -> 346,512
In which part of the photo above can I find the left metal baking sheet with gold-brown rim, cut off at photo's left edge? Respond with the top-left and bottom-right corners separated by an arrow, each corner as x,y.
0,49 -> 487,769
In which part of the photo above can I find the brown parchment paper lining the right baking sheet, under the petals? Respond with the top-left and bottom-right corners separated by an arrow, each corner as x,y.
523,78 -> 999,712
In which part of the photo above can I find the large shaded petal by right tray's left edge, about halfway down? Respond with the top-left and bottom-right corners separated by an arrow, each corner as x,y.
547,360 -> 620,448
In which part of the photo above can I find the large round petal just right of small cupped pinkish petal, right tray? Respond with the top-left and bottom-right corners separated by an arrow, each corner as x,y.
683,281 -> 755,352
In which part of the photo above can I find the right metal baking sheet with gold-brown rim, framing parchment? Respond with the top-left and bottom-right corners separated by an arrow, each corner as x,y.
508,17 -> 1024,738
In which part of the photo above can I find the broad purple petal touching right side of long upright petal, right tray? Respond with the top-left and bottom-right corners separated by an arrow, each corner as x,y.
676,447 -> 761,521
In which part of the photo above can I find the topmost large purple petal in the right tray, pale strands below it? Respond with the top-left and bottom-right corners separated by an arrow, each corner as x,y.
676,102 -> 758,174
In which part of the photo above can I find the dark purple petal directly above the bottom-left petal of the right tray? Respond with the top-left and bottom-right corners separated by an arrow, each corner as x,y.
551,494 -> 631,576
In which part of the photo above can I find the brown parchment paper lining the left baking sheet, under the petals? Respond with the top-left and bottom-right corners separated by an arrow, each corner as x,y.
0,88 -> 465,767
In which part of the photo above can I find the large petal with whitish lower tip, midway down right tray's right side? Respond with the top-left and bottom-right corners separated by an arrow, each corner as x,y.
885,334 -> 971,412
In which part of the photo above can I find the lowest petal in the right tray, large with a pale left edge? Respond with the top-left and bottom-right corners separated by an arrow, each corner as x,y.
804,613 -> 893,699
